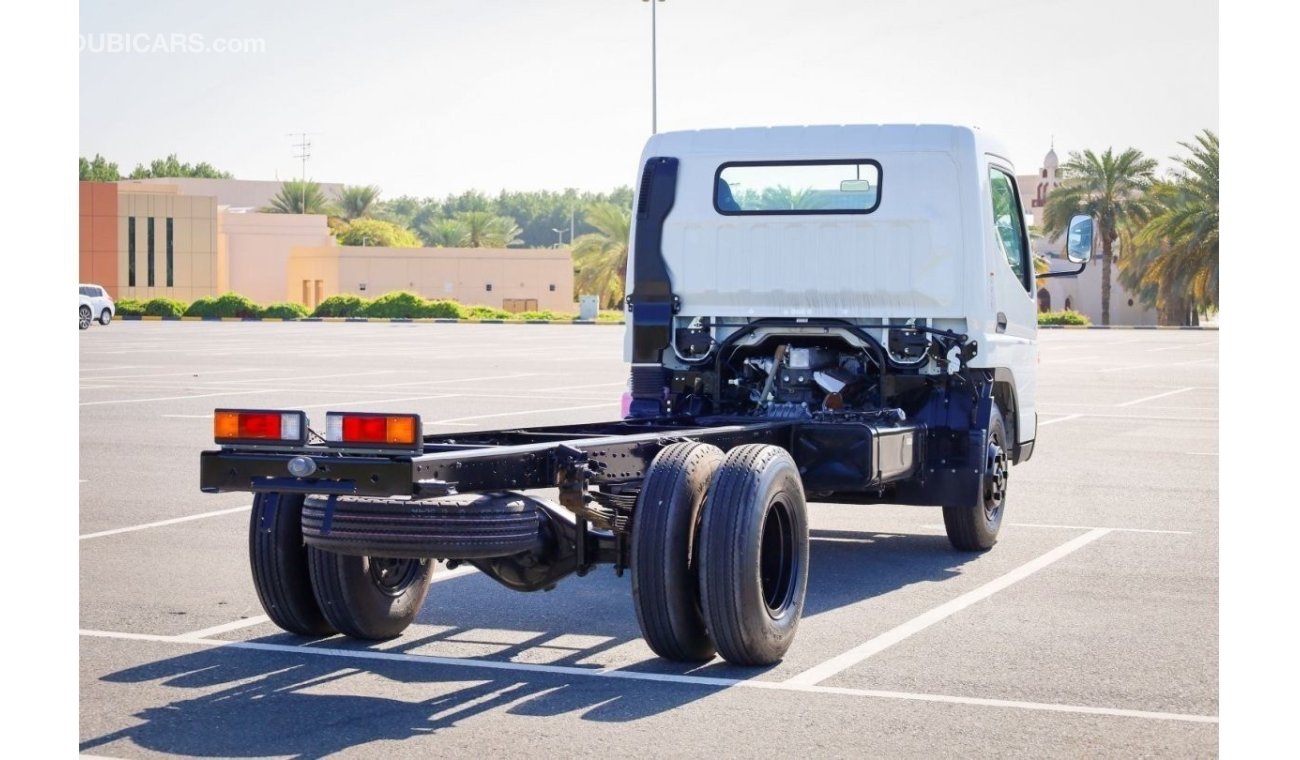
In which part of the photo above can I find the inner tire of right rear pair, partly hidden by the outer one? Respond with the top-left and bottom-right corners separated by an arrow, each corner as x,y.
632,443 -> 723,663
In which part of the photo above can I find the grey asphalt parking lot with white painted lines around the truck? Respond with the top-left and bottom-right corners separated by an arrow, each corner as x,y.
79,322 -> 1219,757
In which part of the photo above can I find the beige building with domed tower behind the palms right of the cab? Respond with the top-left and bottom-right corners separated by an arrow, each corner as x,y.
1015,148 -> 1158,325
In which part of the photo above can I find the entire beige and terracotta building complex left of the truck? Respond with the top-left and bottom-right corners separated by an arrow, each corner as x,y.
79,179 -> 576,312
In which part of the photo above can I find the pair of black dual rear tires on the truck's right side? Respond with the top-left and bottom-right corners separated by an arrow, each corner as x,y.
631,443 -> 809,665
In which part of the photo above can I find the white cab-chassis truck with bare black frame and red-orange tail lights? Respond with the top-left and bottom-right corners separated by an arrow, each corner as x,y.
200,125 -> 1093,665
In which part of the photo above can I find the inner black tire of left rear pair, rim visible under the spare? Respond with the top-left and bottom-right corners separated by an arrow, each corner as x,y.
307,547 -> 433,640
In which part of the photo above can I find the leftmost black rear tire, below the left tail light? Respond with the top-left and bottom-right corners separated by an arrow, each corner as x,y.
248,494 -> 334,637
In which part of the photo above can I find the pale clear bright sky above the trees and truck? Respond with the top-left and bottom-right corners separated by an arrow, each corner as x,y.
78,0 -> 1219,197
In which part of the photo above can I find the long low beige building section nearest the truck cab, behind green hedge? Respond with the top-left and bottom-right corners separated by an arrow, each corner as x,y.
289,246 -> 575,312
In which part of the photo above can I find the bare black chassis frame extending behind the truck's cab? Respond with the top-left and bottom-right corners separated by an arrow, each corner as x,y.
200,417 -> 924,500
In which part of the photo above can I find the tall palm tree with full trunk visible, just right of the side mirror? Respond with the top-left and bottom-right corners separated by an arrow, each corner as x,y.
1043,148 -> 1156,325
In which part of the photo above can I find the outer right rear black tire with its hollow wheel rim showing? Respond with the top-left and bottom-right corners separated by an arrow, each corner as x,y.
699,444 -> 809,665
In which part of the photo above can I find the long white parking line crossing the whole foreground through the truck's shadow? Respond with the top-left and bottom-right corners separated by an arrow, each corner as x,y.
78,629 -> 1219,724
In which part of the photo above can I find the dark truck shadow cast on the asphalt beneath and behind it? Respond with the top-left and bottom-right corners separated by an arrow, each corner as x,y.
81,530 -> 974,757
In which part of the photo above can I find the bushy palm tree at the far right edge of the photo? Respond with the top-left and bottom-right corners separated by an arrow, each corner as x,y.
1136,130 -> 1218,323
